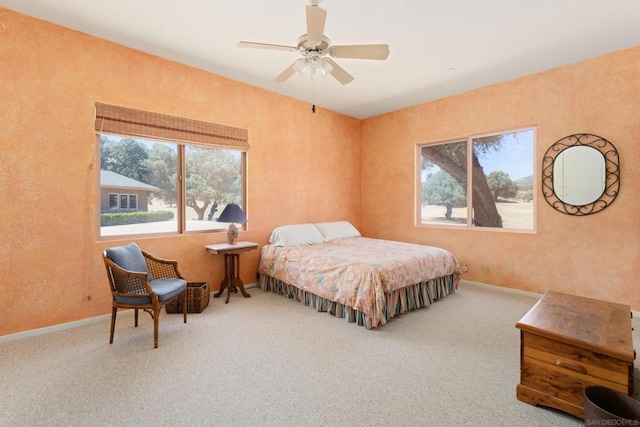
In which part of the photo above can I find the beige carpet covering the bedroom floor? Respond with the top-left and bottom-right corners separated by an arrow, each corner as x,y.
0,284 -> 639,426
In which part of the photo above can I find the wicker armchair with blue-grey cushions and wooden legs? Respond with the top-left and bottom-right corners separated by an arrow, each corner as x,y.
103,243 -> 187,348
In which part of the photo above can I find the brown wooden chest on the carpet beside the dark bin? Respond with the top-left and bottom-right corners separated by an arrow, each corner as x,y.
516,291 -> 635,418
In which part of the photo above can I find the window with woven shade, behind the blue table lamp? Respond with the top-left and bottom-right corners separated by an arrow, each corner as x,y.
96,104 -> 248,236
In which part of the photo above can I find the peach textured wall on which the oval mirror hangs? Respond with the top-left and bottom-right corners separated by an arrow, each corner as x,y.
362,47 -> 640,310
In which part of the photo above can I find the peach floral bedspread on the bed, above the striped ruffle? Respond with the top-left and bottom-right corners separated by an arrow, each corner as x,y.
258,237 -> 458,326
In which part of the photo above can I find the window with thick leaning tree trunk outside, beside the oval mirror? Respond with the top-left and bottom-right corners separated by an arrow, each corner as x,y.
416,128 -> 535,231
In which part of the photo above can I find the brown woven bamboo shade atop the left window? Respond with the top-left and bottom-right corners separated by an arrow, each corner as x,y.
96,102 -> 249,151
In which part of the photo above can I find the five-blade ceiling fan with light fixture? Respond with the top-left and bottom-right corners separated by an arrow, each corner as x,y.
238,0 -> 389,85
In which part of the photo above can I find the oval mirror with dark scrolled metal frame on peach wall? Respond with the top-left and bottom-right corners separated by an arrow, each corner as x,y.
542,133 -> 620,216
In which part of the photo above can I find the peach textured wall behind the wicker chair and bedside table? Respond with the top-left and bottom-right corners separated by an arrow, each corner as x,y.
0,8 -> 361,336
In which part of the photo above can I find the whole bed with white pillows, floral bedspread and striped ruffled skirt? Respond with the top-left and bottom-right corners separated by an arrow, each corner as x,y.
258,221 -> 459,329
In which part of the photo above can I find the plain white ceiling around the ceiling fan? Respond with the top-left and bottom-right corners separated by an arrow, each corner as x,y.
0,0 -> 640,119
